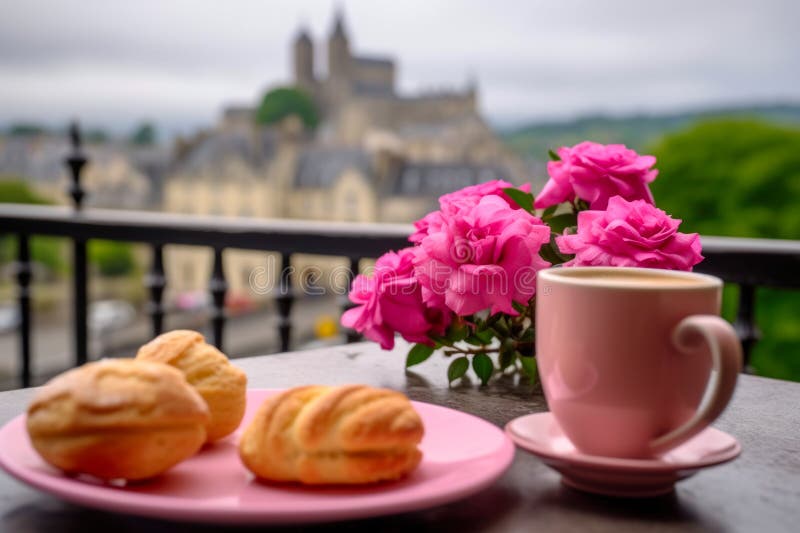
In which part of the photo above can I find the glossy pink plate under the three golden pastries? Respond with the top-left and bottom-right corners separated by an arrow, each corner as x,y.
0,390 -> 514,524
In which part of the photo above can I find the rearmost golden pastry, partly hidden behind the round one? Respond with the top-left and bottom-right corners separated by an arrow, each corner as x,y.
136,329 -> 247,442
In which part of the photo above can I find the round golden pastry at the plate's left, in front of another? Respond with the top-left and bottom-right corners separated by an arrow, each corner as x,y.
27,359 -> 209,480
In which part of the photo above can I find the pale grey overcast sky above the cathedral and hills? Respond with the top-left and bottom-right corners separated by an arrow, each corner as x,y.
0,0 -> 800,137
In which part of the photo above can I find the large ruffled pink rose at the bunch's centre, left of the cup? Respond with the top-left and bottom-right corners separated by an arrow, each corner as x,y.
414,195 -> 550,316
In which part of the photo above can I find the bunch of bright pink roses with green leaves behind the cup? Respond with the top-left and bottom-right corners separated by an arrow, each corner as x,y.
341,142 -> 703,384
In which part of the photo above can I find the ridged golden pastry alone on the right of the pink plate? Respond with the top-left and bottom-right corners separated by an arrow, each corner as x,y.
239,385 -> 424,484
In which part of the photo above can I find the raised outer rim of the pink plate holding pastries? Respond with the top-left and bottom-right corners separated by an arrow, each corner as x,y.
0,387 -> 516,525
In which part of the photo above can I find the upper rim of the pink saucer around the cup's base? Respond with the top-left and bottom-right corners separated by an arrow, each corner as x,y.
504,411 -> 742,473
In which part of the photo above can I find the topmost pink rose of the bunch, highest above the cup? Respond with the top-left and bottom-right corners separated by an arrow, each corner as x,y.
534,141 -> 658,209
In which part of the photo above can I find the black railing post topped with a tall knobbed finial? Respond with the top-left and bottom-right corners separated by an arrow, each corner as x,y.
65,122 -> 89,365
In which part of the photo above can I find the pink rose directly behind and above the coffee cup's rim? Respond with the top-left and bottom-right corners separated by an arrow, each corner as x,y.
556,196 -> 703,270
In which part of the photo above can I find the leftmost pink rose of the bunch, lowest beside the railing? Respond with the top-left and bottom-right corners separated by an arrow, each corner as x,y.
341,248 -> 450,350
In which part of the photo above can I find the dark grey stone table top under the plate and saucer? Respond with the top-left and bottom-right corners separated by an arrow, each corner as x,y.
0,343 -> 800,533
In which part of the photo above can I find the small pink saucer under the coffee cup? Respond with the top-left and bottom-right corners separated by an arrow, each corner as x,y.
506,413 -> 742,498
